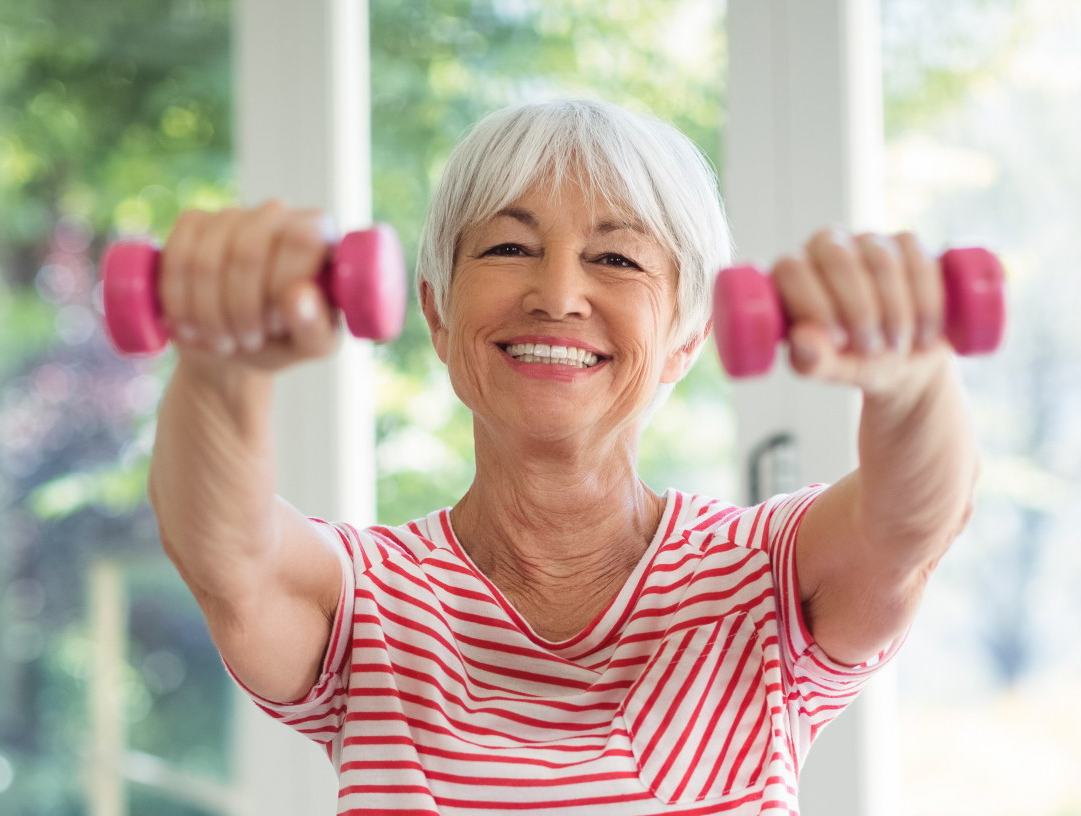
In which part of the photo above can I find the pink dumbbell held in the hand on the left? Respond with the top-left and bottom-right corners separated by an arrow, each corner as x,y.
102,224 -> 406,355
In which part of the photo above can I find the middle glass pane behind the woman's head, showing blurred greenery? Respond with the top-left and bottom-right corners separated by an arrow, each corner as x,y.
371,0 -> 735,523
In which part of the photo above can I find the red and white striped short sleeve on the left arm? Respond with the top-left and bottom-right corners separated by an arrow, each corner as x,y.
226,519 -> 357,758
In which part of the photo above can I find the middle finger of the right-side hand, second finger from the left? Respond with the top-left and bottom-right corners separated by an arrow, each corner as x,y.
806,229 -> 885,355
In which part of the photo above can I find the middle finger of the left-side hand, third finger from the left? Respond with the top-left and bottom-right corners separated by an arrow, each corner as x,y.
223,201 -> 286,352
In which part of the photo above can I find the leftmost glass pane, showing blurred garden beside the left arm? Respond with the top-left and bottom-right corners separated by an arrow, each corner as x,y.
0,0 -> 231,816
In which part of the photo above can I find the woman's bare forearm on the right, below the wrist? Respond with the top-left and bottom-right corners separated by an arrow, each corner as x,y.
857,352 -> 977,567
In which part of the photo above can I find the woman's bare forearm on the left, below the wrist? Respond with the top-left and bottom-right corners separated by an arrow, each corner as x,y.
149,358 -> 279,598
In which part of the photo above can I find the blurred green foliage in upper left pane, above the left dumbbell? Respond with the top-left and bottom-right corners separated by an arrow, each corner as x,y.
0,0 -> 231,264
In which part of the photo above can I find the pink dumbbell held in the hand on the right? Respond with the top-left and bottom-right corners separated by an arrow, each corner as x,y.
713,248 -> 1005,377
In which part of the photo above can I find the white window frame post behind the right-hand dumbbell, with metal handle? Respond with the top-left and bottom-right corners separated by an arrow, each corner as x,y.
723,0 -> 897,816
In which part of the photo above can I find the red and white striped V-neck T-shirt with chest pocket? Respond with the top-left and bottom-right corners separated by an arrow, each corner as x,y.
238,487 -> 896,816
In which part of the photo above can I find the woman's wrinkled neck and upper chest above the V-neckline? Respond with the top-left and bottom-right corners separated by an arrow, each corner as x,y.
452,427 -> 664,634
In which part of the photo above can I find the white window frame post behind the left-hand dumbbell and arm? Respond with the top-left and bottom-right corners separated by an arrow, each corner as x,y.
233,0 -> 375,816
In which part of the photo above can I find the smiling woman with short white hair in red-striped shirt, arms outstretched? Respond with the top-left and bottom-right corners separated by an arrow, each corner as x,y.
150,102 -> 976,816
